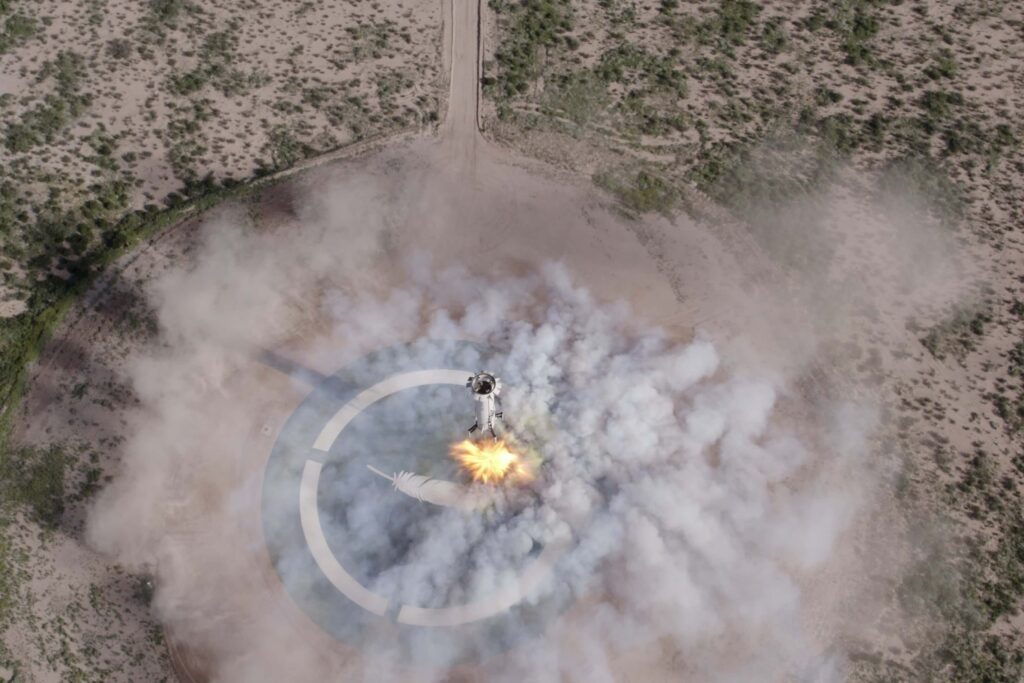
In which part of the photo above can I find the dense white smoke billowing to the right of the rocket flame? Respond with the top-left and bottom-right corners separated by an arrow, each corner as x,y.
317,264 -> 866,681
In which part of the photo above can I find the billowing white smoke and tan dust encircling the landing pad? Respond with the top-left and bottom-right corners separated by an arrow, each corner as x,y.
83,153 -> 868,681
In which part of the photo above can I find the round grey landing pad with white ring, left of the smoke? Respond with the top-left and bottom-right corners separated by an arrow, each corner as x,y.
261,340 -> 563,663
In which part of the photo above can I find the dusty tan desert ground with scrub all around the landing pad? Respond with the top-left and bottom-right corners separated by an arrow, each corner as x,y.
0,0 -> 1024,681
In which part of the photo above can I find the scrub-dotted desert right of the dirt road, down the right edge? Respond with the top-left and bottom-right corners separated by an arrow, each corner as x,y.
485,0 -> 1024,682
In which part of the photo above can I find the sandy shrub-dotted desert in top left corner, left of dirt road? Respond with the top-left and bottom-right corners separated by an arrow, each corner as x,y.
0,0 -> 442,310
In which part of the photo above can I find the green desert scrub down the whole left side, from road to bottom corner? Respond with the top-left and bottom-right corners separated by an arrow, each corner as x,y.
0,0 -> 415,681
